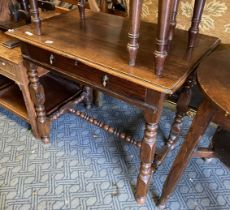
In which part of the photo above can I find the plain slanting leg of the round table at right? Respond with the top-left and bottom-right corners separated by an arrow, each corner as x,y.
158,100 -> 214,208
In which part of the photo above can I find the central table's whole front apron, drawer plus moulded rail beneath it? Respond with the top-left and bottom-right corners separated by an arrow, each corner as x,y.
22,44 -> 159,111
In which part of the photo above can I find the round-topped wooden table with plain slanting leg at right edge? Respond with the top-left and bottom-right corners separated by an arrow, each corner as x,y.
159,45 -> 230,207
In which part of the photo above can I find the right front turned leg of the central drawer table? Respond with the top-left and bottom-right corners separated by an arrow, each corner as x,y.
135,92 -> 165,204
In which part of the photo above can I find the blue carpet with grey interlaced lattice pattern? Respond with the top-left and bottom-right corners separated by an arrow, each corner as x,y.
0,97 -> 230,210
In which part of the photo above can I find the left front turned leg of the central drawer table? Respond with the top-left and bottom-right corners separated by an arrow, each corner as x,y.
24,61 -> 50,144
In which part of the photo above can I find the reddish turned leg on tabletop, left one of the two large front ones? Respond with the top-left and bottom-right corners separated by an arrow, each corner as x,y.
127,0 -> 143,66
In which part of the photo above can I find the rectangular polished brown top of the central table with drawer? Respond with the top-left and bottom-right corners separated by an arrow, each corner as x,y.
7,10 -> 219,94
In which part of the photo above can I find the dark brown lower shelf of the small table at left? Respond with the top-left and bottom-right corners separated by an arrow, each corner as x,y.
0,73 -> 79,122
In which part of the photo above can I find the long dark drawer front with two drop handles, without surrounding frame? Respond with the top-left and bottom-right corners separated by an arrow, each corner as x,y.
23,45 -> 146,102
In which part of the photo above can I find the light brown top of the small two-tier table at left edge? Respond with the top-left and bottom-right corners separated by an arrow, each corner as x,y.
0,31 -> 22,64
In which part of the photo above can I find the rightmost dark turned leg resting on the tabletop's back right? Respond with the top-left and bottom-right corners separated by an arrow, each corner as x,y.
188,0 -> 206,47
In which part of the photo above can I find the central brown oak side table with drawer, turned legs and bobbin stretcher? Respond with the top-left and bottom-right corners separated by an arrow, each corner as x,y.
7,10 -> 219,203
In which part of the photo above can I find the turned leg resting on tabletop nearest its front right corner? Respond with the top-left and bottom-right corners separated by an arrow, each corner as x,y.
154,0 -> 172,76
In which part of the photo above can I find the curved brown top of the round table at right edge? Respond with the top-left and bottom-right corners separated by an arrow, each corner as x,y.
197,45 -> 230,114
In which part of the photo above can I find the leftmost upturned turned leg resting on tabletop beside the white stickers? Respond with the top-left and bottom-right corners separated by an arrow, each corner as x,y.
30,0 -> 42,35
